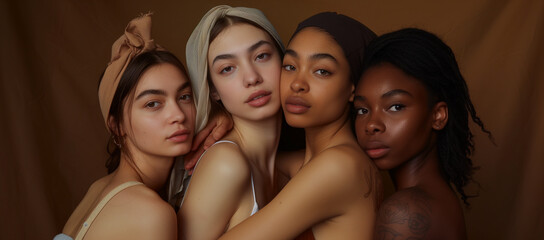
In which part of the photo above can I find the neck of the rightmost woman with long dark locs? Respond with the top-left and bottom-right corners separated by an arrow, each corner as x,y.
389,144 -> 445,190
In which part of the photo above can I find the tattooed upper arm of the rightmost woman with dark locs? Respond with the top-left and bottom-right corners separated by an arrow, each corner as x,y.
374,189 -> 431,240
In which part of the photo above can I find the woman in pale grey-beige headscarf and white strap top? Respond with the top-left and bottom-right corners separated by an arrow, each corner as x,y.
178,6 -> 283,240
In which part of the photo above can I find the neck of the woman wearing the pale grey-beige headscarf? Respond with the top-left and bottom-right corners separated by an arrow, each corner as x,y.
226,113 -> 281,174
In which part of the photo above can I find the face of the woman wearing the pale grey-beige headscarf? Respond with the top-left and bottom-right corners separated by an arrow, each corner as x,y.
208,23 -> 281,121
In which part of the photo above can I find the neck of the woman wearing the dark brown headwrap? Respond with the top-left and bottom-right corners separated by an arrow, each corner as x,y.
304,109 -> 356,164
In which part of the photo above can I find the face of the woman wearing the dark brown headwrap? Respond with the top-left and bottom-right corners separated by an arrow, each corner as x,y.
280,27 -> 353,128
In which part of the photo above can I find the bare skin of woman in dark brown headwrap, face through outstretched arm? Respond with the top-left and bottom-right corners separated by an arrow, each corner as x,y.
216,28 -> 379,239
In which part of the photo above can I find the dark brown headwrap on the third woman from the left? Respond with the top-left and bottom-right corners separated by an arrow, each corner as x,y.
291,12 -> 376,84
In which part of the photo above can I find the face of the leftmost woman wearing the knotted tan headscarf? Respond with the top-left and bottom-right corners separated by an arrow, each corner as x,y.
122,63 -> 196,157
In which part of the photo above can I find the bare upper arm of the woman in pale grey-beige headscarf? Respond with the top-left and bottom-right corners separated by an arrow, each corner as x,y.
178,144 -> 251,239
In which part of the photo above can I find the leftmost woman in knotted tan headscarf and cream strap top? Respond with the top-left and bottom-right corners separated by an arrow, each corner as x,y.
55,14 -> 195,240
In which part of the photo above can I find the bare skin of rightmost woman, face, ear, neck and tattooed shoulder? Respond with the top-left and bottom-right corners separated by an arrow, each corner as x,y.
354,63 -> 466,240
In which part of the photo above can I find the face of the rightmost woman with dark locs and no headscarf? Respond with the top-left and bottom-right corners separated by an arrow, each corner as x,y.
353,63 -> 447,170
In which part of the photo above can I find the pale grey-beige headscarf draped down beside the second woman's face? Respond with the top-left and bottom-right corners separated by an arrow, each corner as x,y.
185,5 -> 284,132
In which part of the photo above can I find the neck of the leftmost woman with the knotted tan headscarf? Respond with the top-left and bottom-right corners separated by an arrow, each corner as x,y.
114,150 -> 174,191
